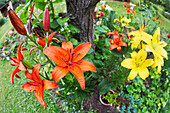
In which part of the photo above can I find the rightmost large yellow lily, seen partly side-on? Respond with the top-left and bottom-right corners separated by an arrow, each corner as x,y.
145,27 -> 168,73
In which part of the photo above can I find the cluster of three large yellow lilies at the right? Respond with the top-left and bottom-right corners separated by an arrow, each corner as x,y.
121,26 -> 168,80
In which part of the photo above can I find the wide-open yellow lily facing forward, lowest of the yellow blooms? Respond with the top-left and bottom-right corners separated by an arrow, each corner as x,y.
121,49 -> 153,80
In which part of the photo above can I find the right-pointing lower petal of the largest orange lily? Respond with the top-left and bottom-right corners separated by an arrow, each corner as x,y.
78,59 -> 97,72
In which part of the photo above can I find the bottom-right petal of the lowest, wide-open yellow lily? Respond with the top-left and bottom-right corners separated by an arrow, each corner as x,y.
139,67 -> 149,80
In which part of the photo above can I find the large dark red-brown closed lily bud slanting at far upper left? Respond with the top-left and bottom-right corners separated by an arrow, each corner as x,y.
8,9 -> 27,35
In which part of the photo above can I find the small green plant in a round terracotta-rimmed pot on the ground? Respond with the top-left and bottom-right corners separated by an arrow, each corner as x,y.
99,90 -> 120,106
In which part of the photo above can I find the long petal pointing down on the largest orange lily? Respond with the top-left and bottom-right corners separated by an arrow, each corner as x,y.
70,65 -> 85,90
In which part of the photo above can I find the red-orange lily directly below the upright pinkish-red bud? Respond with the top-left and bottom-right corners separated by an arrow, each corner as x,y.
29,29 -> 58,55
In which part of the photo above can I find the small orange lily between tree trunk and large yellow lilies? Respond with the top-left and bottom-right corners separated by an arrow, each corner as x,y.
110,37 -> 127,51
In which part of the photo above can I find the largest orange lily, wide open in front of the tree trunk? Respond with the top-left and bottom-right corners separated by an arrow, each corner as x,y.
43,41 -> 97,90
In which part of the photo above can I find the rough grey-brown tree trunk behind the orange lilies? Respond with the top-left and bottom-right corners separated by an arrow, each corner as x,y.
66,0 -> 100,47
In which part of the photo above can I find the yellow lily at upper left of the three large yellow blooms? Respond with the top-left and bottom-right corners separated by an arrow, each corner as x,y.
129,25 -> 152,50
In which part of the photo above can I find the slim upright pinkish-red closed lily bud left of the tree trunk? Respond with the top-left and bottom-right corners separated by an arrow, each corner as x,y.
43,7 -> 50,31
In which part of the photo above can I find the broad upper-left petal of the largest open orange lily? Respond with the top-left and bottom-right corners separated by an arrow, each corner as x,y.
43,46 -> 69,67
